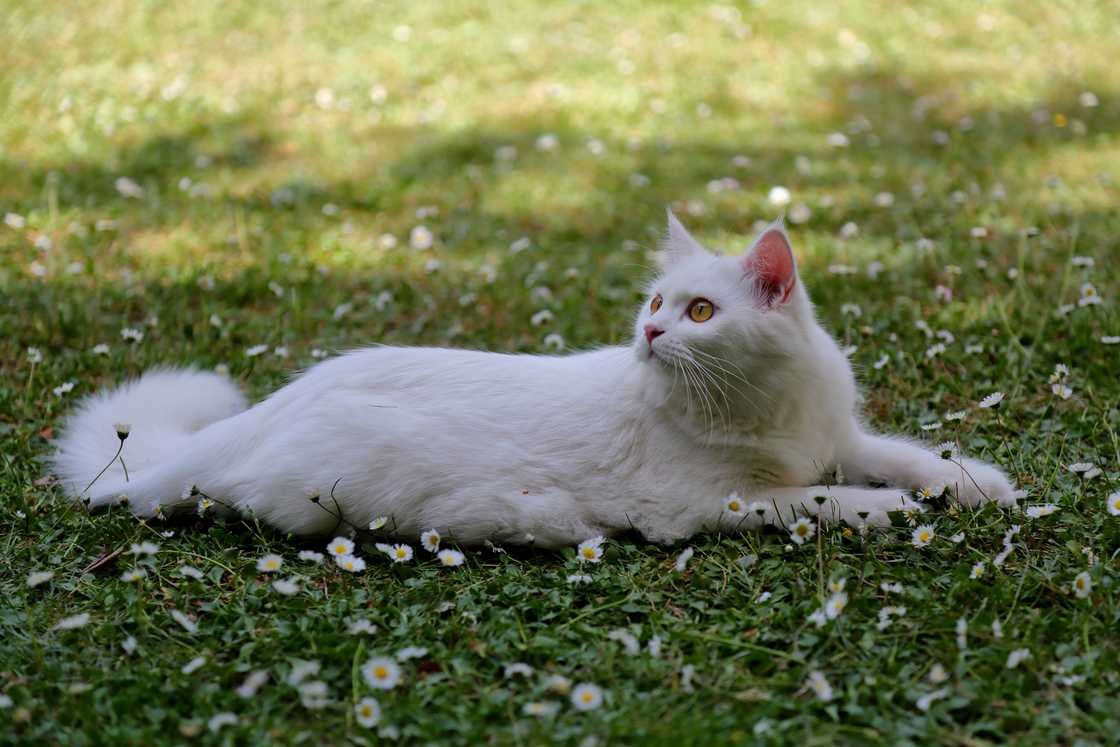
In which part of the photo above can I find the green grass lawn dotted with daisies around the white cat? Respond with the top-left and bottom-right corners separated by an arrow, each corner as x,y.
0,0 -> 1120,745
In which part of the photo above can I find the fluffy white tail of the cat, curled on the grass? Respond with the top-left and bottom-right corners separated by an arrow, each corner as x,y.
52,368 -> 248,499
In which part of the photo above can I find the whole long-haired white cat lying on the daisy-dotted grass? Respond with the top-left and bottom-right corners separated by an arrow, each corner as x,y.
55,214 -> 1015,547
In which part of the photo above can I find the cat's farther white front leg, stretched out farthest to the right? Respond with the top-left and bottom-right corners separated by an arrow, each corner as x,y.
837,432 -> 1017,506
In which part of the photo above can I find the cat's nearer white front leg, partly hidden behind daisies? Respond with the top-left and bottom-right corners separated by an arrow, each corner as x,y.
719,485 -> 923,531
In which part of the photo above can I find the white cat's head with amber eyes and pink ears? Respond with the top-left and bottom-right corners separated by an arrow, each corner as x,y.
633,212 -> 815,385
